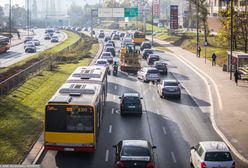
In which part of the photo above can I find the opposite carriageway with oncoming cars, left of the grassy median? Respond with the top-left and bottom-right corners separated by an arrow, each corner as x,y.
0,29 -> 67,68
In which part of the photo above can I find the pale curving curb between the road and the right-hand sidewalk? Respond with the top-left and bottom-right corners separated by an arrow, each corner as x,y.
164,48 -> 248,164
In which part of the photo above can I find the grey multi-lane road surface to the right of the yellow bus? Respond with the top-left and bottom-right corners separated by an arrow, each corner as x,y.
38,34 -> 245,168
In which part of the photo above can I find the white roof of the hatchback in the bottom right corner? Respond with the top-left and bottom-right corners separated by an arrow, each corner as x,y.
199,141 -> 230,152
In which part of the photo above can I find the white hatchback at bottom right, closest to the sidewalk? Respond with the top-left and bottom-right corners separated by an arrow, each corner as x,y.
190,141 -> 235,168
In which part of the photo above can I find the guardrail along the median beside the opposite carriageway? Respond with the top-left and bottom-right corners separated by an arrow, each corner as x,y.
0,32 -> 82,96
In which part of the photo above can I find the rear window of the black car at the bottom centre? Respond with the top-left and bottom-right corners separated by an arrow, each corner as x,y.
121,146 -> 150,156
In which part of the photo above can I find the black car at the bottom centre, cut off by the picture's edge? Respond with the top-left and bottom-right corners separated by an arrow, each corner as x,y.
113,140 -> 156,168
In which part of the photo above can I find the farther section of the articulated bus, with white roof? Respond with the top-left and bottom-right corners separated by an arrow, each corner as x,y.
66,65 -> 108,100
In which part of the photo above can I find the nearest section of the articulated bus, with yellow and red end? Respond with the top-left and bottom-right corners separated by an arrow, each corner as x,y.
44,83 -> 104,152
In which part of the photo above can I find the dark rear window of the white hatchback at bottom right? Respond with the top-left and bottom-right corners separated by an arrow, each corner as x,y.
205,152 -> 232,161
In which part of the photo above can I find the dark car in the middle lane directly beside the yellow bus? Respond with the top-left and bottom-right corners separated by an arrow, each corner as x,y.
119,93 -> 143,116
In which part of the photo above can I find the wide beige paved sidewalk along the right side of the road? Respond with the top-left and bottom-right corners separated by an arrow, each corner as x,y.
150,39 -> 248,163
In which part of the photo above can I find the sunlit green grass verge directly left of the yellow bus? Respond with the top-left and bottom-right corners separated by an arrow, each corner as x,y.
0,35 -> 98,164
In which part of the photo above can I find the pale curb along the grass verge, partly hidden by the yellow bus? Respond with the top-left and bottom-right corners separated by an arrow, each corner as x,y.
21,33 -> 103,165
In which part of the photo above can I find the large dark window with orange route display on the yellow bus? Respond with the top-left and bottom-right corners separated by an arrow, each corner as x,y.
45,105 -> 94,133
